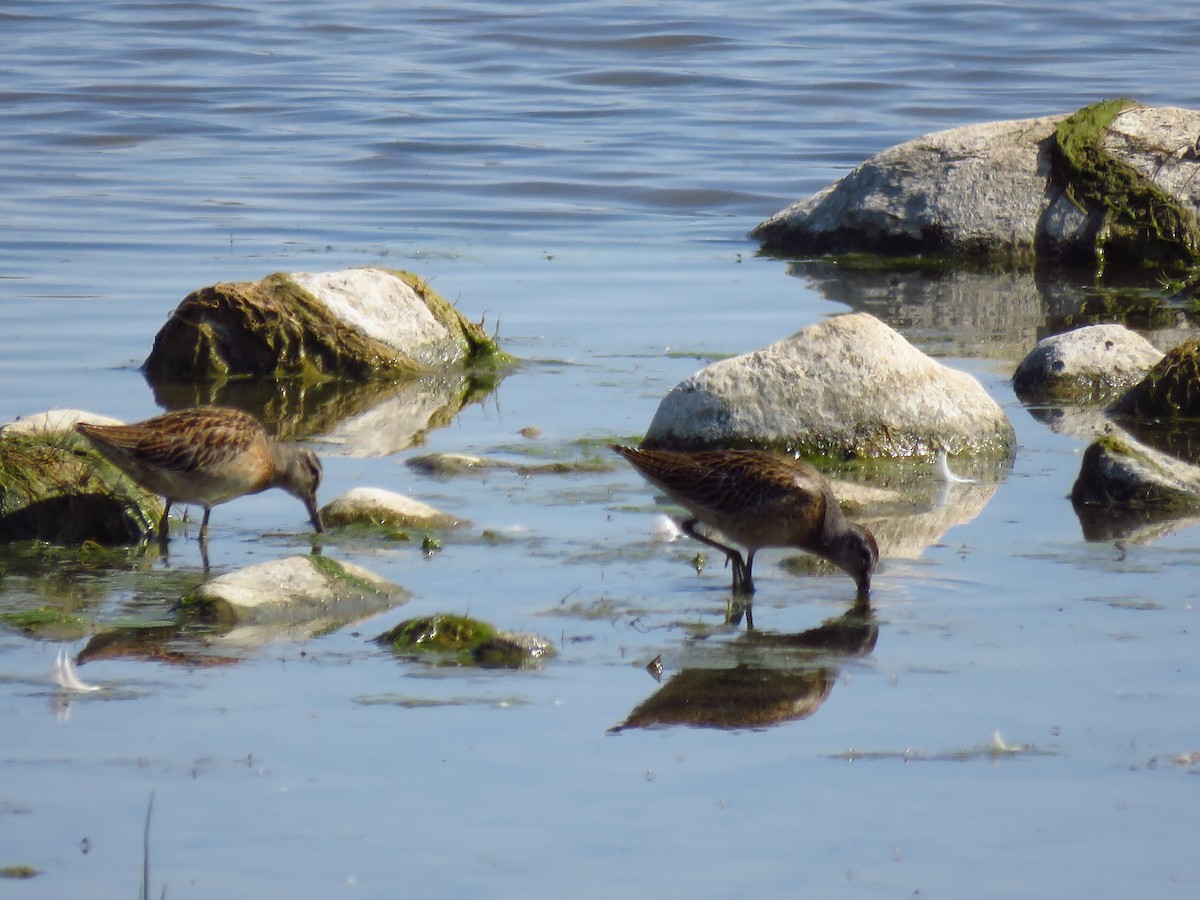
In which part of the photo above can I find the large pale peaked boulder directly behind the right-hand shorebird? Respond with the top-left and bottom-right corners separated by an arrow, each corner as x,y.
643,313 -> 1015,458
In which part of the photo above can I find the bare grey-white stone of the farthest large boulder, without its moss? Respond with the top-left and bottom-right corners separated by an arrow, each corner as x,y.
751,106 -> 1200,264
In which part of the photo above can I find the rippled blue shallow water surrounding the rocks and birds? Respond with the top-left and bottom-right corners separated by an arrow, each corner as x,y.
0,0 -> 1200,898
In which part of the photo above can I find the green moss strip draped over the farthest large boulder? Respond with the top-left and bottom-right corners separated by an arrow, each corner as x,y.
1054,100 -> 1200,269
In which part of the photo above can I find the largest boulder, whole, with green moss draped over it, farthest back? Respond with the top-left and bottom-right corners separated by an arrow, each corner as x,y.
752,101 -> 1200,271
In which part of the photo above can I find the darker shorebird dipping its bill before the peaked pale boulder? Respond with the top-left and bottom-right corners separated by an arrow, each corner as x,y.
612,444 -> 880,599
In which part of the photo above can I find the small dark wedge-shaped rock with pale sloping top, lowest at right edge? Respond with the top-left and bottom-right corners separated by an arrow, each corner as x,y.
1070,434 -> 1200,510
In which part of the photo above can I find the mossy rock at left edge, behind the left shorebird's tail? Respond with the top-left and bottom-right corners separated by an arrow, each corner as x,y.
0,432 -> 162,545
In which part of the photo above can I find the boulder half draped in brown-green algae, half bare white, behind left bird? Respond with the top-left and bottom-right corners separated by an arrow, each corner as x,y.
144,269 -> 506,383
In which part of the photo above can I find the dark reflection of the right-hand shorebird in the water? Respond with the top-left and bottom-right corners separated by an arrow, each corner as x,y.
611,602 -> 880,732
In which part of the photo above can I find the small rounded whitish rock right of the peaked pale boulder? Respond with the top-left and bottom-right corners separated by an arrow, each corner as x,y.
1013,324 -> 1163,404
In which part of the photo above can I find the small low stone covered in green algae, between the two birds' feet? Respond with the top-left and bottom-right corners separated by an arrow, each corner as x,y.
376,613 -> 554,668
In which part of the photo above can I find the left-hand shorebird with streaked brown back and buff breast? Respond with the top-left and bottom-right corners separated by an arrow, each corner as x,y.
76,407 -> 323,542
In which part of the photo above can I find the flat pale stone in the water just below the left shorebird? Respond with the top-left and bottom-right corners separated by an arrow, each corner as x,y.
181,556 -> 408,635
